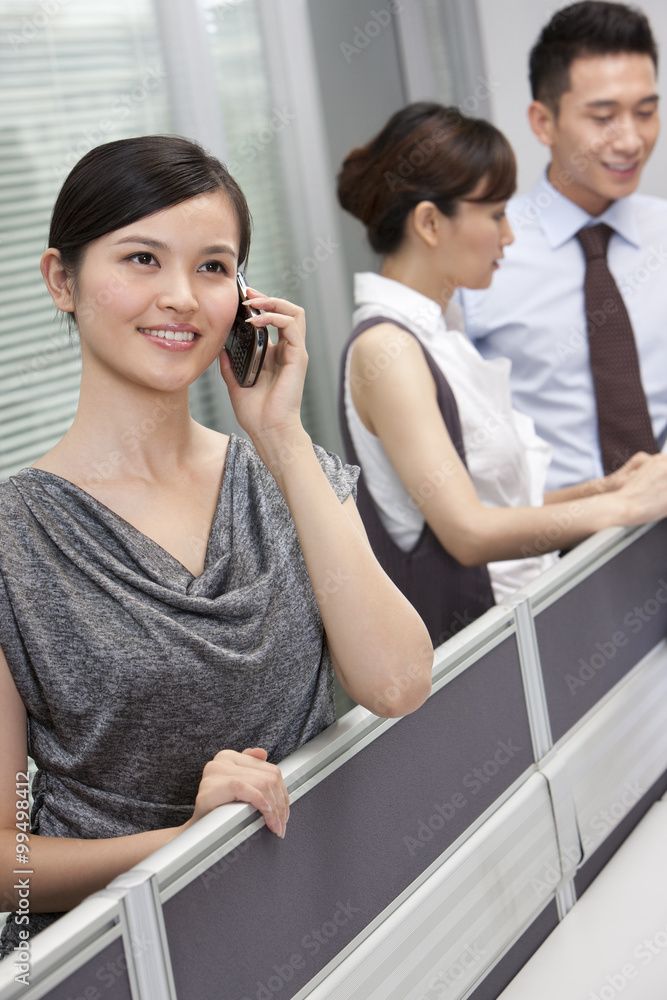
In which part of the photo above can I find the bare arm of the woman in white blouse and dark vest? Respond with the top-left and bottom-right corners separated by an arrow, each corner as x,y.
351,324 -> 667,566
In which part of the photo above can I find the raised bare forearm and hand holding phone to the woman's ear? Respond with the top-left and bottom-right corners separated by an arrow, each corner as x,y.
220,289 -> 433,717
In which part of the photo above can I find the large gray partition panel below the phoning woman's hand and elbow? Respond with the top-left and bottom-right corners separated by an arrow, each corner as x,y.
164,636 -> 533,1000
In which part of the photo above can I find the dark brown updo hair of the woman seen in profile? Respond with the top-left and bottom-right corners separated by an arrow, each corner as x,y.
338,101 -> 516,254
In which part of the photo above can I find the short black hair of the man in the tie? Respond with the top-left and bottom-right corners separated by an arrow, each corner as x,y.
530,0 -> 658,114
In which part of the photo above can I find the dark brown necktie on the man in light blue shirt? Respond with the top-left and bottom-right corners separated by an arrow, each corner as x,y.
577,222 -> 658,475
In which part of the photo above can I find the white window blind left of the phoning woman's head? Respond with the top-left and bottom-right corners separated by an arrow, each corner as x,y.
0,0 -> 169,480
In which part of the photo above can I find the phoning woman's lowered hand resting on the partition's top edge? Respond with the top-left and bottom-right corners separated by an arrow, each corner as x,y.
181,747 -> 289,837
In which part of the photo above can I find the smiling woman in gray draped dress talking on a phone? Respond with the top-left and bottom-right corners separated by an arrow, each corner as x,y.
0,136 -> 432,954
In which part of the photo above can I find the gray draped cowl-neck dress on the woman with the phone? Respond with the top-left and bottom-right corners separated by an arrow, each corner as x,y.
0,435 -> 358,957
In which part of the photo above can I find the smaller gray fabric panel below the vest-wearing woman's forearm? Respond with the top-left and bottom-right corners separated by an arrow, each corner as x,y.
535,521 -> 667,741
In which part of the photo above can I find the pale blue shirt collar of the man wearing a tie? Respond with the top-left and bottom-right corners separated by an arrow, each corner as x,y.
529,171 -> 641,250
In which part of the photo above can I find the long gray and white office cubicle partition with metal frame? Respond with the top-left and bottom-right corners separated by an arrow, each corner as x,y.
0,523 -> 667,1000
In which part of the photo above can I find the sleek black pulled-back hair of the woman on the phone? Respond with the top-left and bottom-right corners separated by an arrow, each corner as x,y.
49,135 -> 251,302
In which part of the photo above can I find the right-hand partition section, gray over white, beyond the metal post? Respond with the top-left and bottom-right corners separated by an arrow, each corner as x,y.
516,521 -> 667,917
